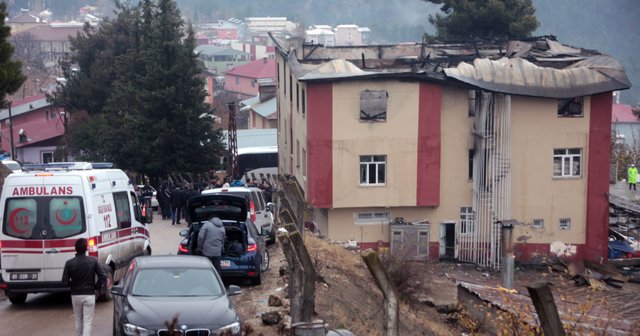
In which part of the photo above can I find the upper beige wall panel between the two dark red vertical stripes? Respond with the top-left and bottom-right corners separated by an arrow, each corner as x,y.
333,80 -> 419,208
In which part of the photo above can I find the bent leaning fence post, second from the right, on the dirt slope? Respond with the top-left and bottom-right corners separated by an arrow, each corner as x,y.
360,249 -> 400,336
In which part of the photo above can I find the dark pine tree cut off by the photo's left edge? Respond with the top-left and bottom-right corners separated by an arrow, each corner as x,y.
0,2 -> 27,106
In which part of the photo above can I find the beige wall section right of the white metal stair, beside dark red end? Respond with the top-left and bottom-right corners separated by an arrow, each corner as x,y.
511,96 -> 590,244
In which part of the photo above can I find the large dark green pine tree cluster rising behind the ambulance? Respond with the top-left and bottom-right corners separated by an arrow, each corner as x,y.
55,0 -> 223,177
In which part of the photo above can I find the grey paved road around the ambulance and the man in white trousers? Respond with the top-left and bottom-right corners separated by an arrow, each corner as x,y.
0,213 -> 186,336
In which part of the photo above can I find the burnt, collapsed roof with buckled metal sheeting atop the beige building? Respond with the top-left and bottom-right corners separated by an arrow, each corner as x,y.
272,36 -> 631,98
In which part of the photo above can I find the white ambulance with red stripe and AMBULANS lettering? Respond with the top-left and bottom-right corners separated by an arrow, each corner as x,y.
0,162 -> 151,304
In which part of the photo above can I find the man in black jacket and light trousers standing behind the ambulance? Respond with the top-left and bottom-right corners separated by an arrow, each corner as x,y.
62,238 -> 108,336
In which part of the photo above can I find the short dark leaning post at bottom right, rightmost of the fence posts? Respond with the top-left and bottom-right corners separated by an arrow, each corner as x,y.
527,281 -> 565,336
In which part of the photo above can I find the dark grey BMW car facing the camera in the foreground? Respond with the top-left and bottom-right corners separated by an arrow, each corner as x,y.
111,255 -> 242,336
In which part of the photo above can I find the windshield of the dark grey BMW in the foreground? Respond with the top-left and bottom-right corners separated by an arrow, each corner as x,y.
131,268 -> 222,296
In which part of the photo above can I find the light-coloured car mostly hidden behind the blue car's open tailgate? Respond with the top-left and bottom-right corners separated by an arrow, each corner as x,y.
202,187 -> 276,245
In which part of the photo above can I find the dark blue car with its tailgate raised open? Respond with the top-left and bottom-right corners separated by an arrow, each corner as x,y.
178,193 -> 269,285
